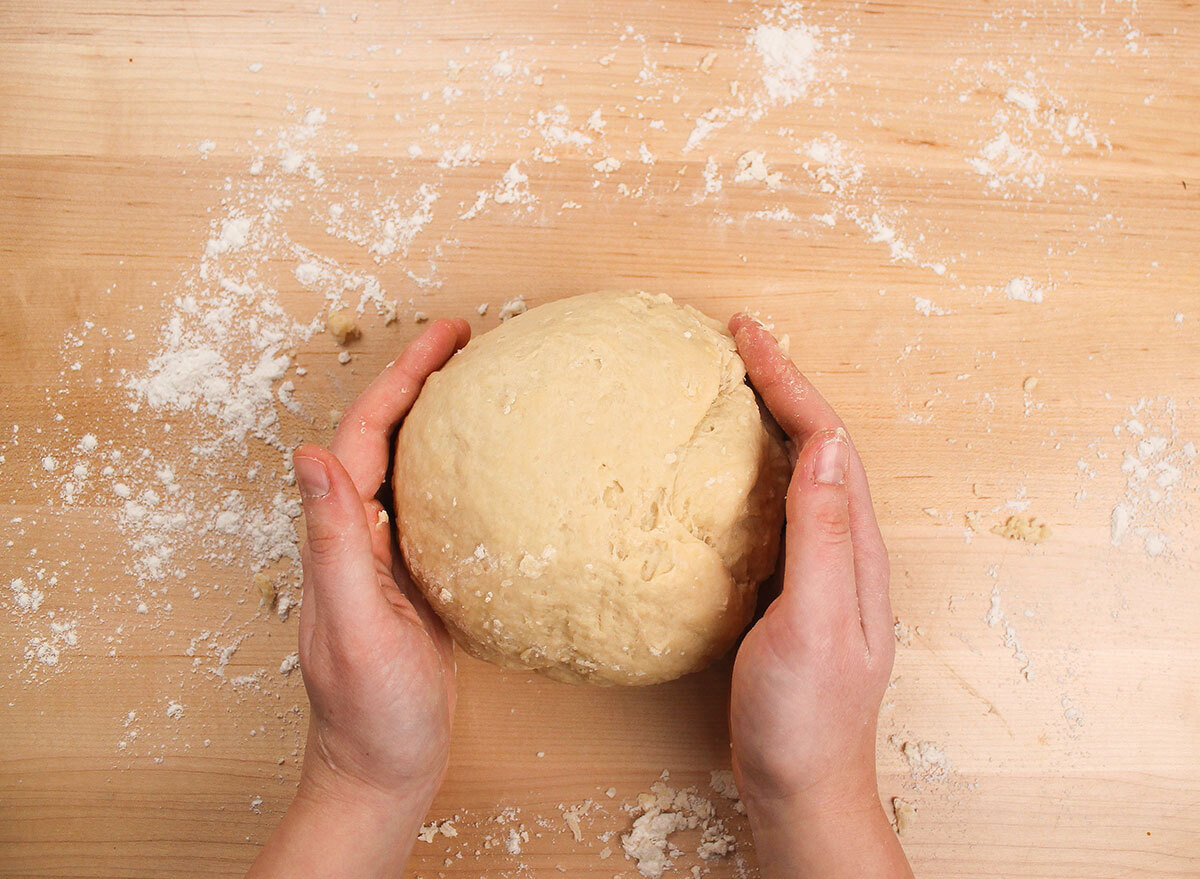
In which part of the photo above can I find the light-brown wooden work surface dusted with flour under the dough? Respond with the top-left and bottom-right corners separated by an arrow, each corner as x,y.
0,0 -> 1200,879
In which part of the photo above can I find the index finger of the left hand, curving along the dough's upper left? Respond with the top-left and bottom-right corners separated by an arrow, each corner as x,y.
330,318 -> 470,500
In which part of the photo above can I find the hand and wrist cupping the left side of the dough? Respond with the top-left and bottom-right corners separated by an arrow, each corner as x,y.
251,321 -> 470,877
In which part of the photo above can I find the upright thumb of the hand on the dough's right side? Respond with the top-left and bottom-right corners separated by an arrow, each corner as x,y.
784,427 -> 858,635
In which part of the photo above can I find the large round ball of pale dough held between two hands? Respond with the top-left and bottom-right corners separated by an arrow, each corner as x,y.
395,292 -> 790,684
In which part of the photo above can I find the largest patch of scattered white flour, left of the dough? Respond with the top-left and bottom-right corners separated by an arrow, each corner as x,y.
0,108 -> 443,686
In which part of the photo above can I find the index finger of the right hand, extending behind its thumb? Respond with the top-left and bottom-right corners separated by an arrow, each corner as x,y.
730,313 -> 893,648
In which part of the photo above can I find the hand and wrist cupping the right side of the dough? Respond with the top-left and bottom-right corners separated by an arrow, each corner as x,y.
730,315 -> 911,878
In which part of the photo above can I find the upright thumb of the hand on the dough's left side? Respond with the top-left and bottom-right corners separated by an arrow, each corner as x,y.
292,446 -> 382,627
